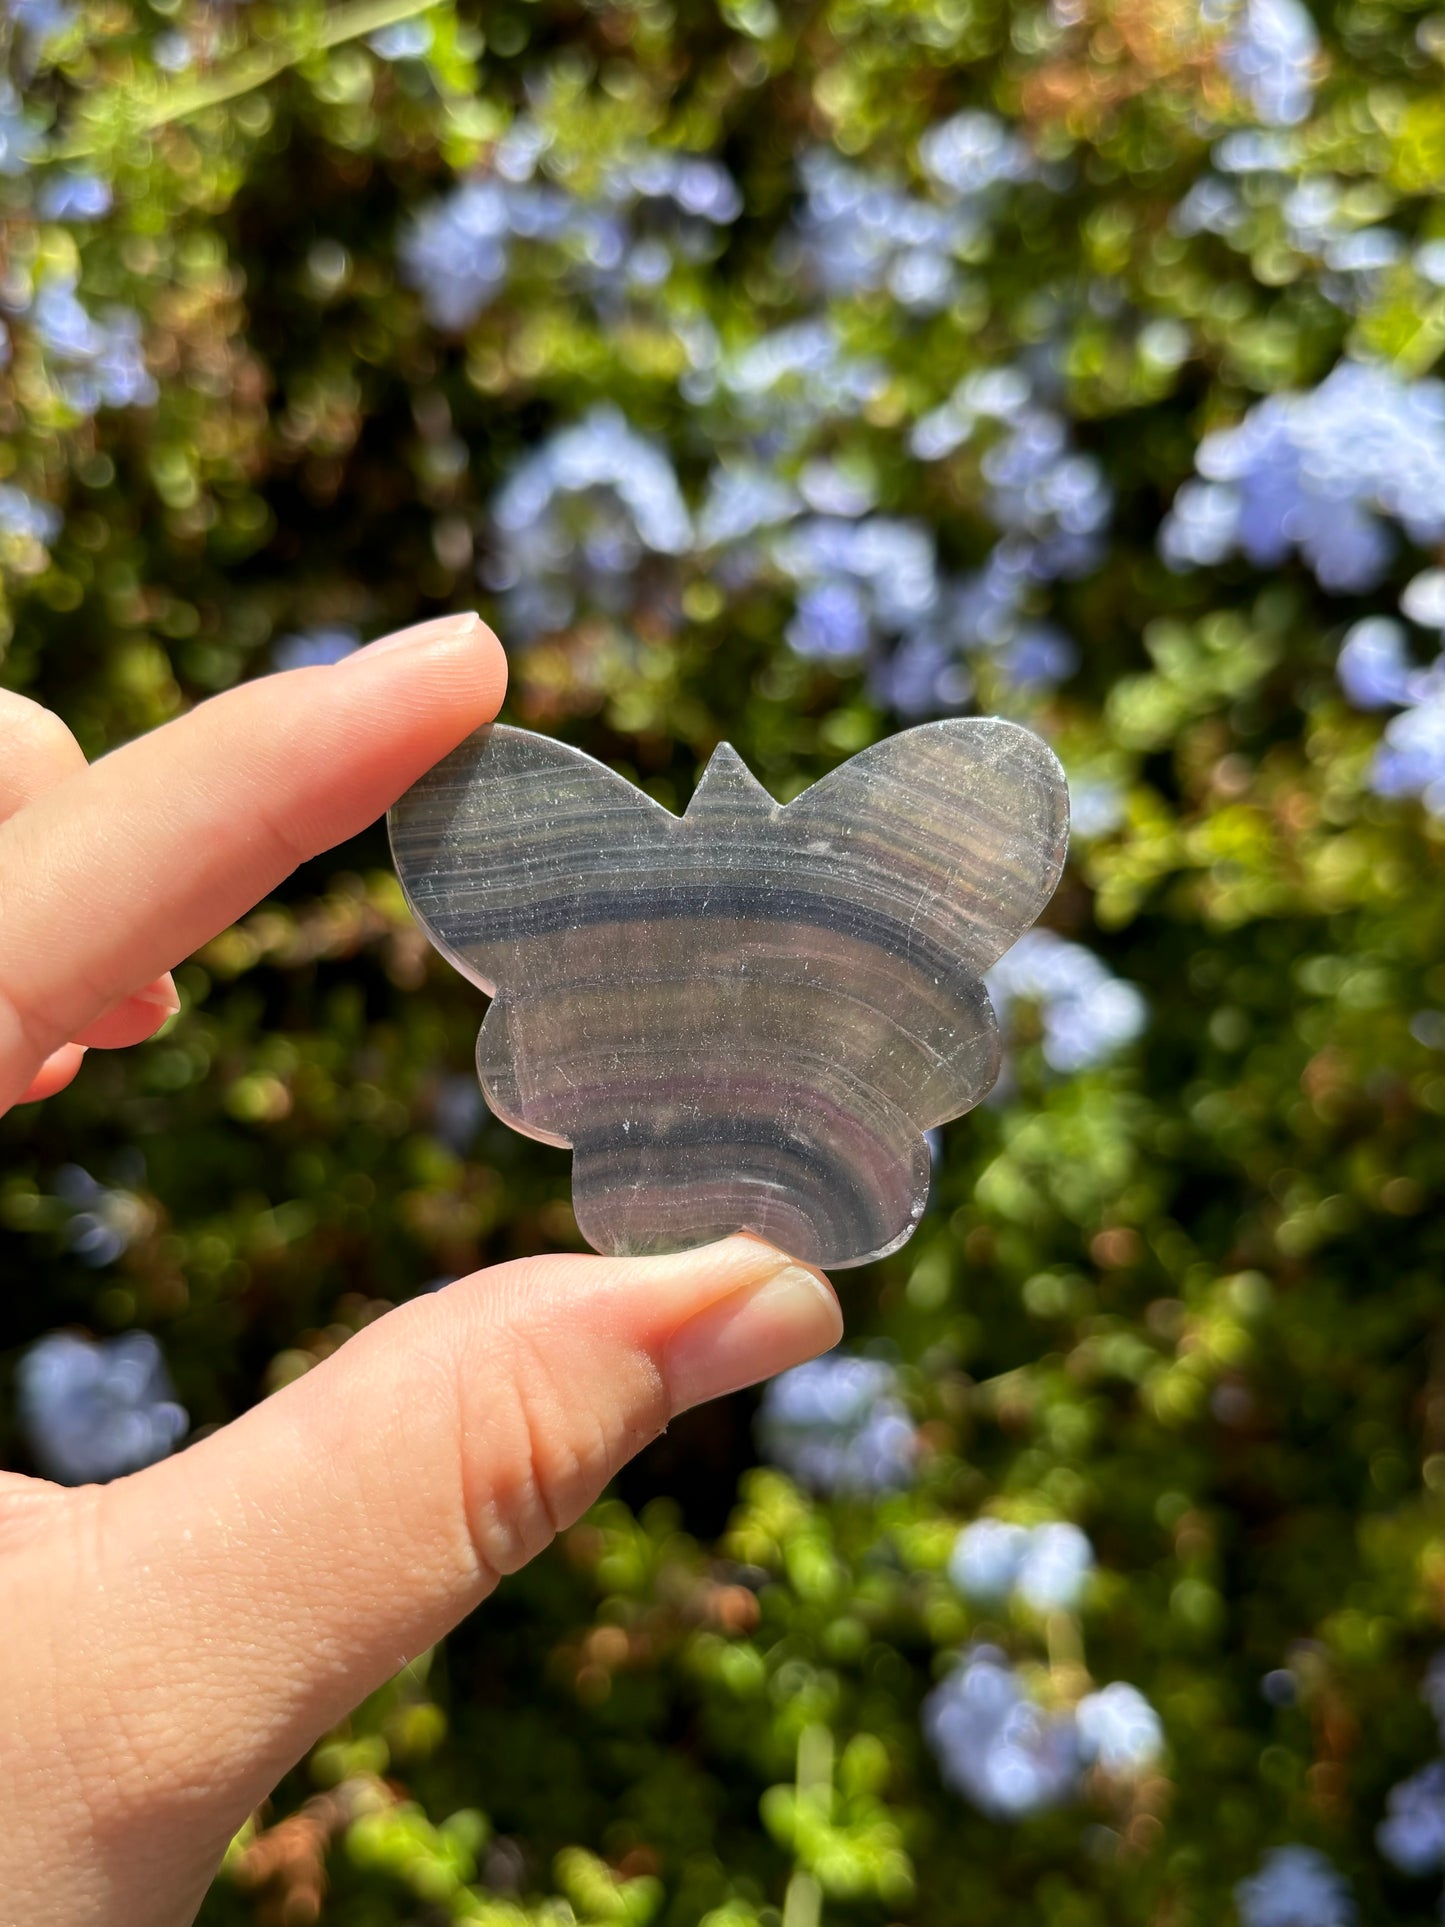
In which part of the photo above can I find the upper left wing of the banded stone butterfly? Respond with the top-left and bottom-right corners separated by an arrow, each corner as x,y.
387,723 -> 676,996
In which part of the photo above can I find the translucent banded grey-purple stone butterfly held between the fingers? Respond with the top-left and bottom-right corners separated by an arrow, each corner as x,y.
389,719 -> 1067,1266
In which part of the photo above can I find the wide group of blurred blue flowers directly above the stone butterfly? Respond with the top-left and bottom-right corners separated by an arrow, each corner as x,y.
484,362 -> 1112,715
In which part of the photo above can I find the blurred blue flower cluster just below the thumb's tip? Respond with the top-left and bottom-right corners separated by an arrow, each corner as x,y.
757,1353 -> 917,1497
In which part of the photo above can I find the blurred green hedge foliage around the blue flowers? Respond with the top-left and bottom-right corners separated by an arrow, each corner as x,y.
0,0 -> 1445,1927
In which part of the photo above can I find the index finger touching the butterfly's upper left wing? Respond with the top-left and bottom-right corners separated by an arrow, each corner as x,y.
0,615 -> 507,1110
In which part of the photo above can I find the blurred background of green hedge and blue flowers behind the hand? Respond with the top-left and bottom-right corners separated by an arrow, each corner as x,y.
0,0 -> 1445,1927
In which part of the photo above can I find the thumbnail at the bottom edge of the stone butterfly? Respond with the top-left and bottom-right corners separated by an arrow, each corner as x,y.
665,1264 -> 842,1412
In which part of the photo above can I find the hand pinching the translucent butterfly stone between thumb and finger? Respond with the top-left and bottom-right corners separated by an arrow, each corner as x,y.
0,617 -> 840,1927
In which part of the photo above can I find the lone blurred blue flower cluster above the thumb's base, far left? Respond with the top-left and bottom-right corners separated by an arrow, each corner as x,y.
17,1332 -> 187,1486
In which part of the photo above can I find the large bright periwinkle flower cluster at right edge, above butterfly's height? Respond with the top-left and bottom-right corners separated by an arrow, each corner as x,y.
1160,360 -> 1445,594
